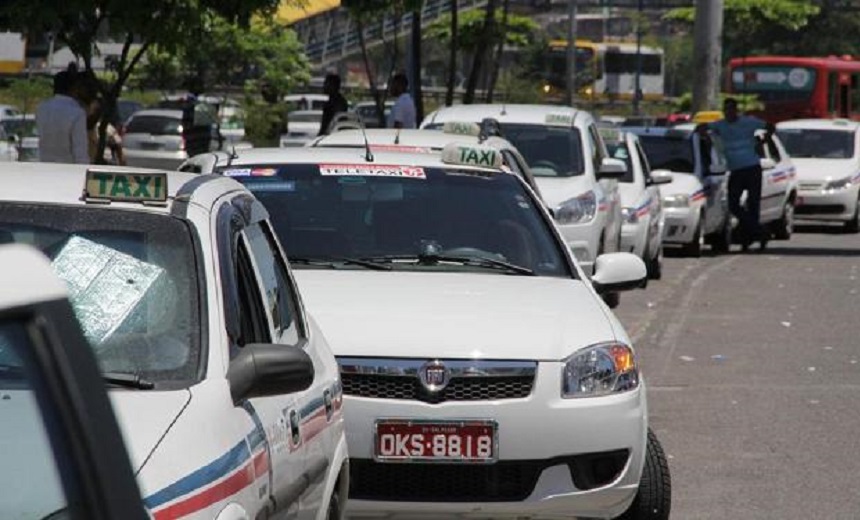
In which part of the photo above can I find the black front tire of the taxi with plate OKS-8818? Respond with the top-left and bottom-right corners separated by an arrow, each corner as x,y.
617,428 -> 672,520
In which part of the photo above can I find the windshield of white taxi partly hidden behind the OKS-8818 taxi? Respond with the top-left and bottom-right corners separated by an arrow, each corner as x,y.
494,124 -> 585,177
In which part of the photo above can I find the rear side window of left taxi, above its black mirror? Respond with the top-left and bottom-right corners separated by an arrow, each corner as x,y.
245,224 -> 300,345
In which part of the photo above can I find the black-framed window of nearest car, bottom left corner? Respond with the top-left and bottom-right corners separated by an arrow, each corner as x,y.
0,320 -> 70,518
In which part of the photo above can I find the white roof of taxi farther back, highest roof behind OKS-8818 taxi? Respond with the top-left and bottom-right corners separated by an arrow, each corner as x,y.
422,104 -> 593,125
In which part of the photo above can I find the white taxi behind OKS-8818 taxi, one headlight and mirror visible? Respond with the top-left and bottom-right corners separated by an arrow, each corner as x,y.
421,105 -> 626,274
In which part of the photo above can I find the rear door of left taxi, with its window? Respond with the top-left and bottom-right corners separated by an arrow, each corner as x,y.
243,220 -> 336,518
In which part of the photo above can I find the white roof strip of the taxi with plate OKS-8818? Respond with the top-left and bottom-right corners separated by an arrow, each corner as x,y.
208,147 -> 513,175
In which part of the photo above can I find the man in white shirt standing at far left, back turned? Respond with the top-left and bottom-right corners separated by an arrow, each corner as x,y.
36,64 -> 90,164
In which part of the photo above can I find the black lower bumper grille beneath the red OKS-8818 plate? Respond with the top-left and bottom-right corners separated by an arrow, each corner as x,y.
349,459 -> 544,502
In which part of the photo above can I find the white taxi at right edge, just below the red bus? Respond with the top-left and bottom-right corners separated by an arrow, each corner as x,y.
776,119 -> 860,233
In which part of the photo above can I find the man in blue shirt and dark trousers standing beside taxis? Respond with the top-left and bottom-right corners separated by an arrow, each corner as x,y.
696,98 -> 775,251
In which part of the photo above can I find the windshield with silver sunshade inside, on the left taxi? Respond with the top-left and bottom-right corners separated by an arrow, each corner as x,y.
0,203 -> 201,384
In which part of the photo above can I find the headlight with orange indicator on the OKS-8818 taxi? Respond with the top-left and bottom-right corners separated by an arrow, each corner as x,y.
561,343 -> 639,398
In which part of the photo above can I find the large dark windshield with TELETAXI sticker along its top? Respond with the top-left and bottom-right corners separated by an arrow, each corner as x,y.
224,164 -> 570,277
